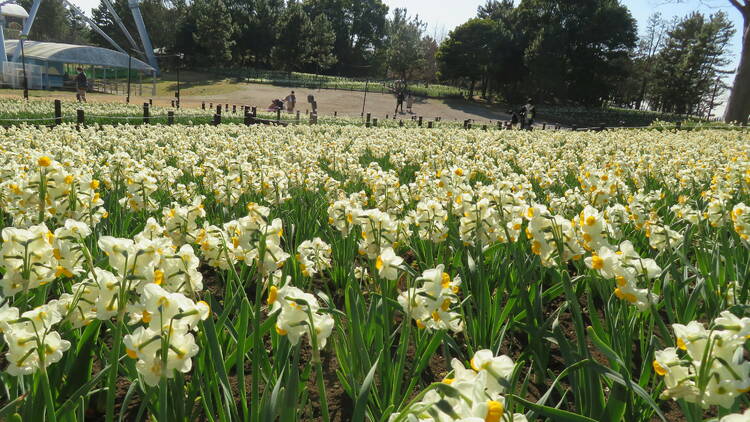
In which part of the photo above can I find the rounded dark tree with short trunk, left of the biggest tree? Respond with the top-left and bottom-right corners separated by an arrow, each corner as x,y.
437,19 -> 496,97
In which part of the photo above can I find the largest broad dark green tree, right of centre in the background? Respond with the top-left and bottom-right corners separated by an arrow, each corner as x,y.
516,0 -> 637,105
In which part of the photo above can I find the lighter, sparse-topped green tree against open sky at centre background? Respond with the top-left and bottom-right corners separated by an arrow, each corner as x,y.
386,9 -> 426,81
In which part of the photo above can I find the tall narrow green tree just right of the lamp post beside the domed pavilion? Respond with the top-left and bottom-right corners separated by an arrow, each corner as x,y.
190,0 -> 235,67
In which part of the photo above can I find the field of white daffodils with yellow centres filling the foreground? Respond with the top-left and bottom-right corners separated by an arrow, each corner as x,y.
0,124 -> 750,422
